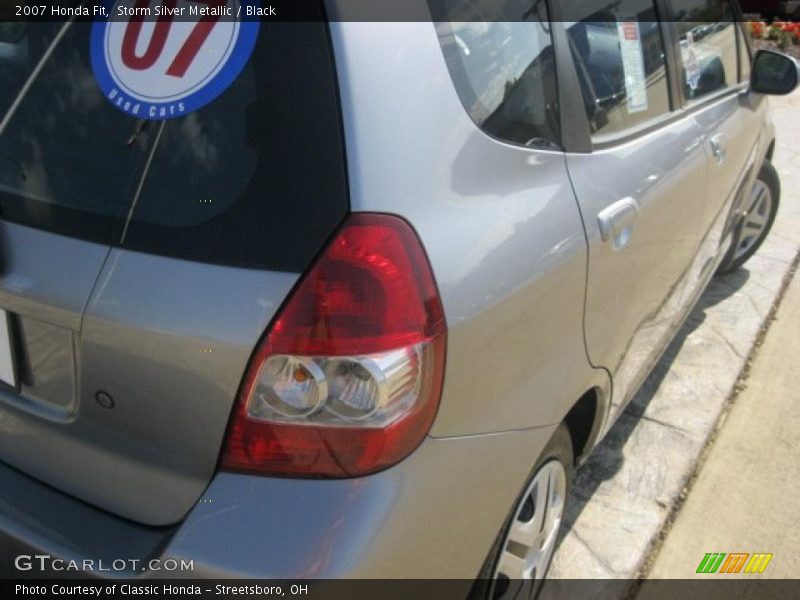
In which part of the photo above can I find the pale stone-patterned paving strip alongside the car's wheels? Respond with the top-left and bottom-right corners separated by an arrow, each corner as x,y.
549,93 -> 800,579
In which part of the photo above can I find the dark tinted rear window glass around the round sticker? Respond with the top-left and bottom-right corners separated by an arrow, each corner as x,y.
0,16 -> 348,271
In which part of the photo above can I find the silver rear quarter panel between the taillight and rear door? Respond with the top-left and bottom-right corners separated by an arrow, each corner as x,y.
332,22 -> 598,437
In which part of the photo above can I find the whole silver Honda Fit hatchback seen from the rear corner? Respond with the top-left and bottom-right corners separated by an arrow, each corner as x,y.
0,0 -> 798,597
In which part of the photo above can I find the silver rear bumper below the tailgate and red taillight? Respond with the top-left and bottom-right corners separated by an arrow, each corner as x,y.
0,427 -> 554,579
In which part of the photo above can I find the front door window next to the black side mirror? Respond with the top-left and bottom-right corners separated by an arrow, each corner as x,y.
672,0 -> 739,100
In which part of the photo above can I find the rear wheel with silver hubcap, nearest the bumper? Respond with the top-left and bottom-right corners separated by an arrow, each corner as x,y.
470,423 -> 574,600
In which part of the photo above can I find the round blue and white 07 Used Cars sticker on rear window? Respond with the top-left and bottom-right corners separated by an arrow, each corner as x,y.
91,0 -> 260,121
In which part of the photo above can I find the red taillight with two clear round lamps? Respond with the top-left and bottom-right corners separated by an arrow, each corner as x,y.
222,214 -> 446,477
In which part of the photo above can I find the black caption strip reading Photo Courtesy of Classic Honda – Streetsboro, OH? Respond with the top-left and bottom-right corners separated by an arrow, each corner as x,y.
0,575 -> 800,600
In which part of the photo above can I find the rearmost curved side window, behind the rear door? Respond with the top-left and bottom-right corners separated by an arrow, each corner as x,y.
431,0 -> 561,149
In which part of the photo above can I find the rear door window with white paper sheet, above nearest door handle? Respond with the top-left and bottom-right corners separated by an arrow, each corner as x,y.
566,0 -> 671,138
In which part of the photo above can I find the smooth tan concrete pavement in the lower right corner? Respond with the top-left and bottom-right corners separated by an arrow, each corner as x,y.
650,264 -> 800,579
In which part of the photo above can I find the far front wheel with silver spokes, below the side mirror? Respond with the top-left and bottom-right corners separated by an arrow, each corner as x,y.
717,161 -> 781,275
